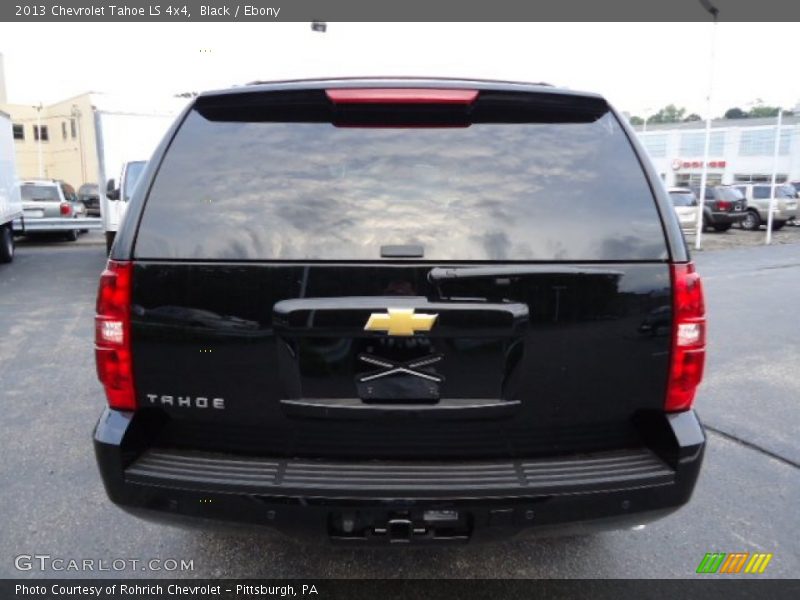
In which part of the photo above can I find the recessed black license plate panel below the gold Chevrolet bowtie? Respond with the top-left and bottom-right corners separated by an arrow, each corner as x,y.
273,297 -> 528,404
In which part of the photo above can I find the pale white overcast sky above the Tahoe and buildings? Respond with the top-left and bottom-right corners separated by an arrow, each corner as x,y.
0,23 -> 800,115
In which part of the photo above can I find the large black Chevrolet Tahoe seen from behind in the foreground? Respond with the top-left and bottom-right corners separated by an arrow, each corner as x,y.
94,79 -> 705,543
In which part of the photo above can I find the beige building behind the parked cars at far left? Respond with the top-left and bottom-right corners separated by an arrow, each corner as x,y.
0,93 -> 98,189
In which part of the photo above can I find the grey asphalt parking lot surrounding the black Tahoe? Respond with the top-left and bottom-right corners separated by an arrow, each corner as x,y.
0,233 -> 800,578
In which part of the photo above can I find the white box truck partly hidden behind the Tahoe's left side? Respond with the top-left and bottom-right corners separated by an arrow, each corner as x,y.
92,94 -> 188,251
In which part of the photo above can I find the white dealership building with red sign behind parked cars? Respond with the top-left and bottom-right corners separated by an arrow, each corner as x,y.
635,116 -> 800,186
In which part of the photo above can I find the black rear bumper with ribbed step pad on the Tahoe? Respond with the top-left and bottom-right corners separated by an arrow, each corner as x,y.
94,409 -> 705,544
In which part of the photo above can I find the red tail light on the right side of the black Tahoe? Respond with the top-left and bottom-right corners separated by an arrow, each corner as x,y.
664,263 -> 706,412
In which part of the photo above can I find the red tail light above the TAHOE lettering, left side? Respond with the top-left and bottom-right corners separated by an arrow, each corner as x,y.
95,260 -> 136,410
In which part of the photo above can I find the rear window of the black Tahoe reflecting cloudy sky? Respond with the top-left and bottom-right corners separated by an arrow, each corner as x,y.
135,93 -> 666,261
